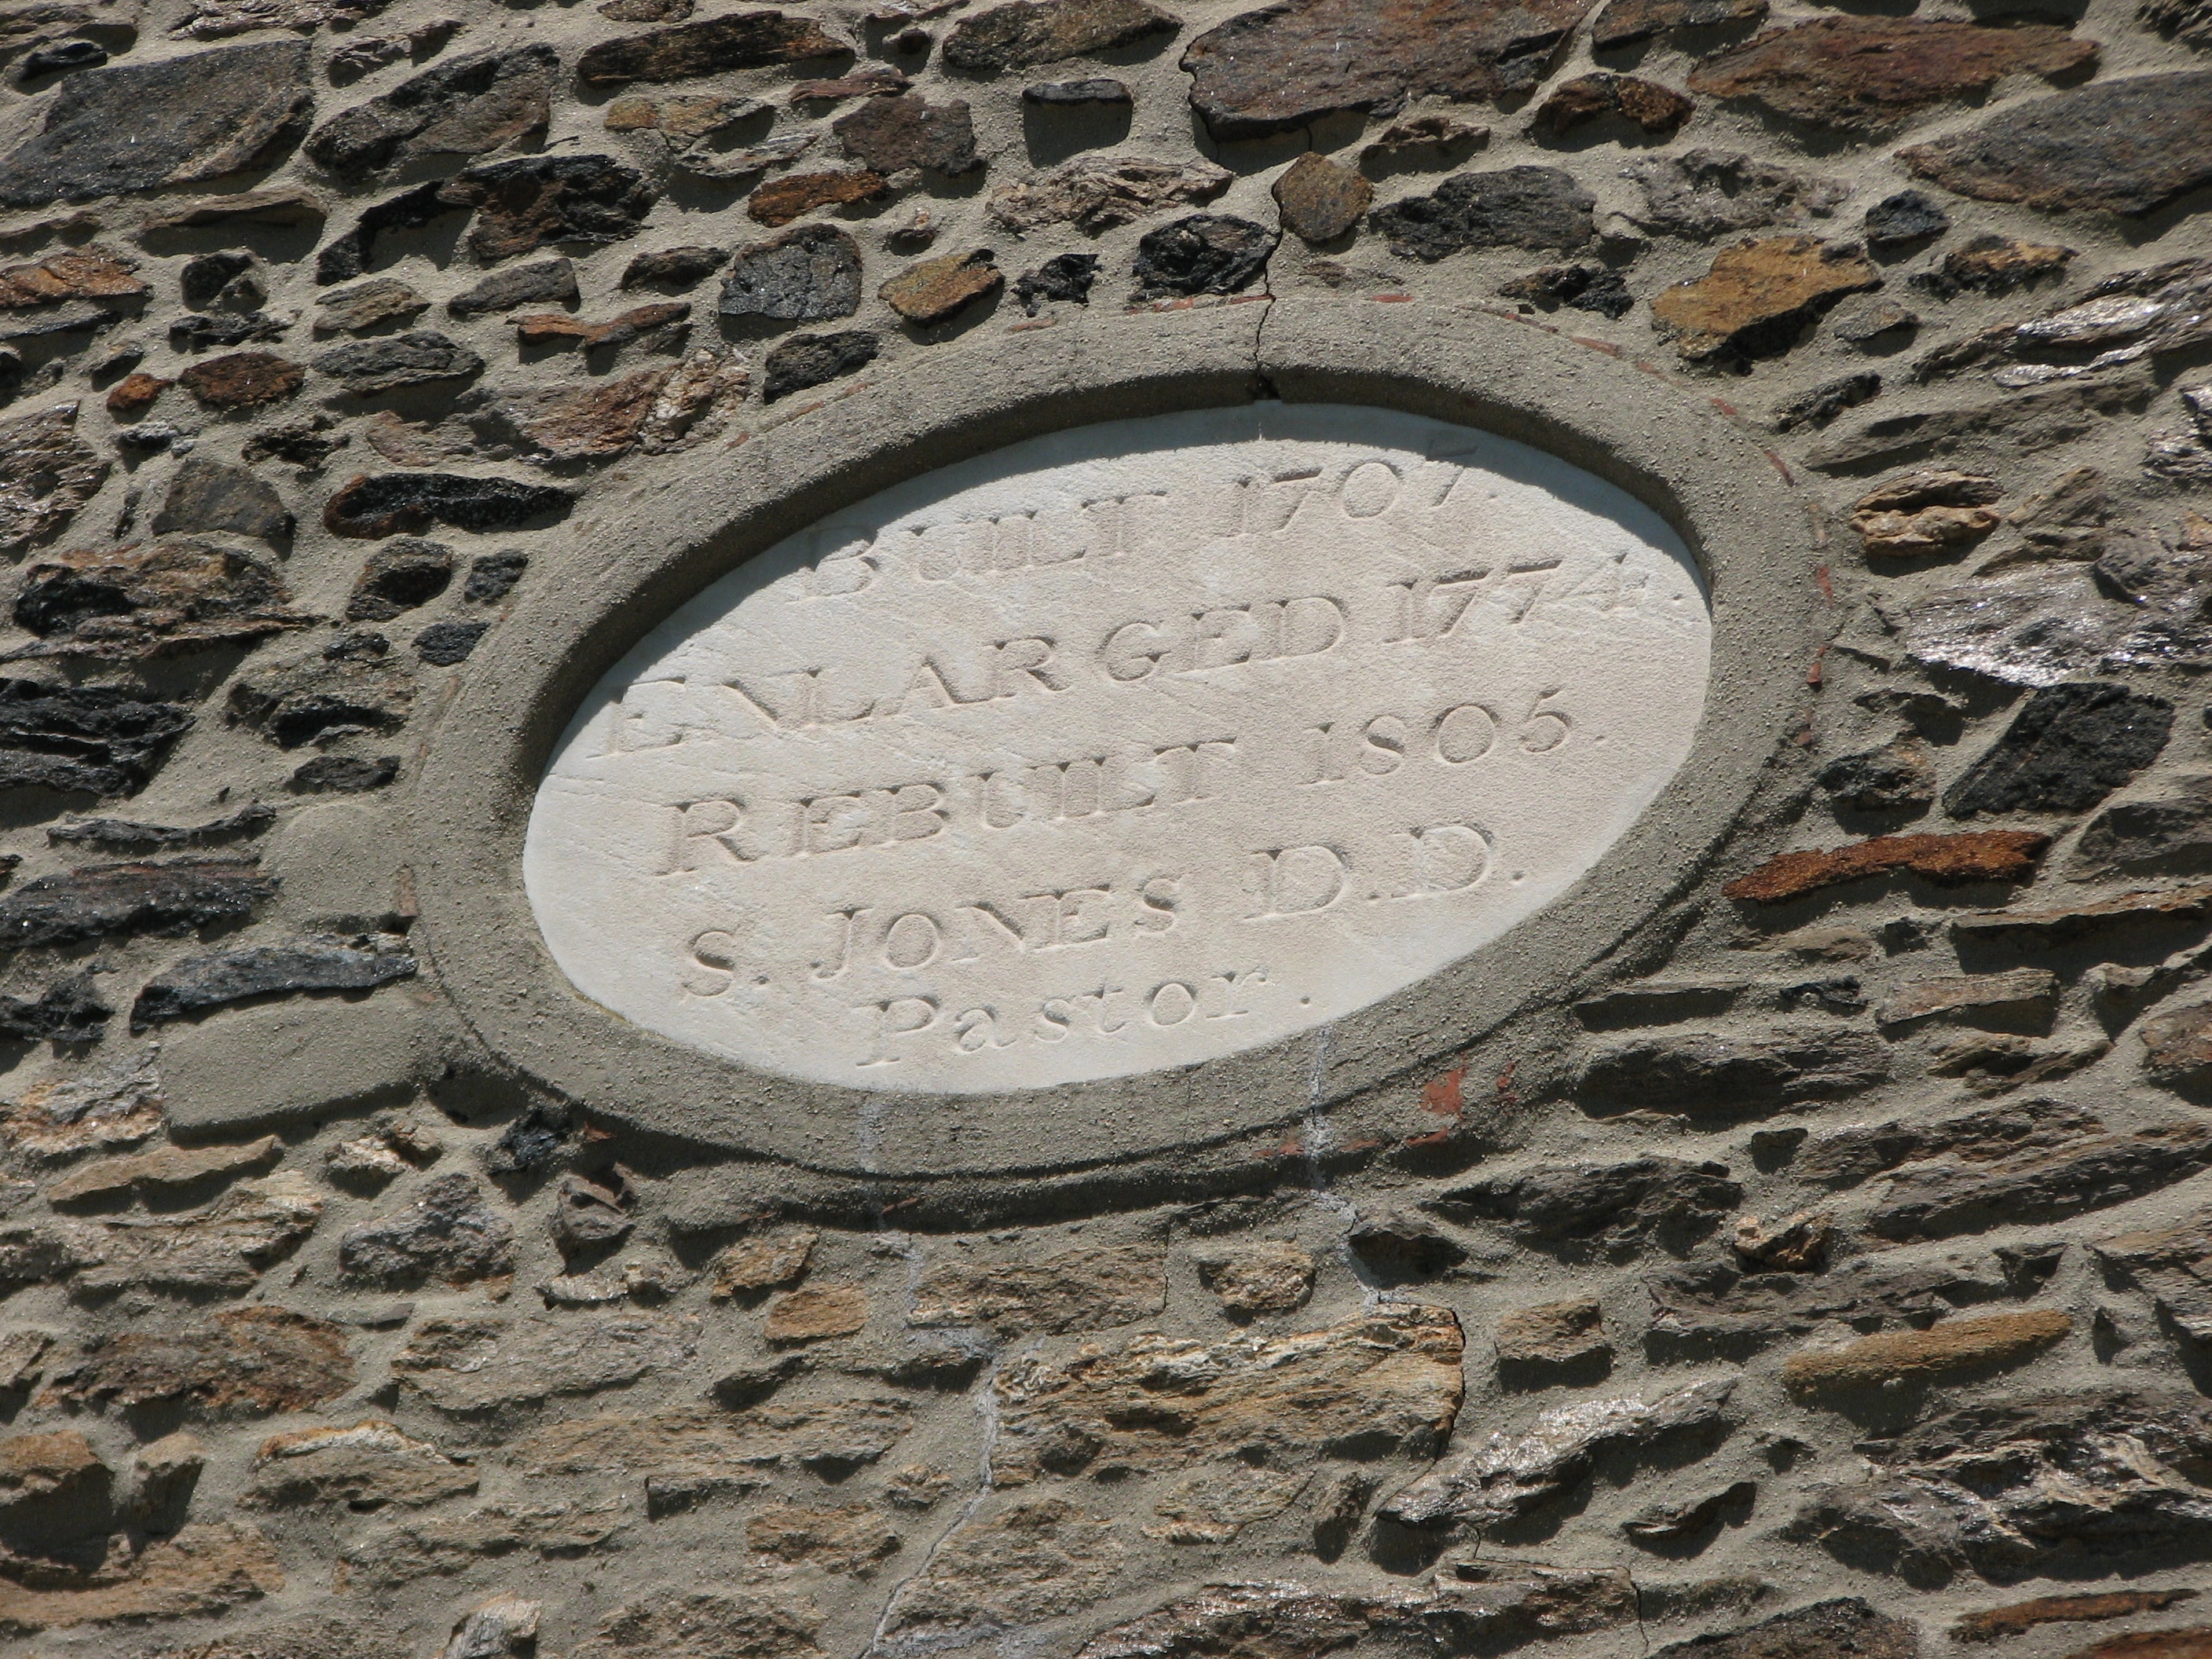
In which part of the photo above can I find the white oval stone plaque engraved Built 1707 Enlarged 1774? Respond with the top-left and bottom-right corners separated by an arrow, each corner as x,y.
524,405 -> 1712,1095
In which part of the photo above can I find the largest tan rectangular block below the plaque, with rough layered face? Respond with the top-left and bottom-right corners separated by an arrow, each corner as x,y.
991,1303 -> 1462,1485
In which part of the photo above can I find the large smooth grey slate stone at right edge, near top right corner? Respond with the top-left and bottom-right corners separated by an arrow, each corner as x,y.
1898,68 -> 2212,217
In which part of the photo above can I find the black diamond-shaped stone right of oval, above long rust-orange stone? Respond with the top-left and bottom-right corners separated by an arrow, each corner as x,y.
1942,681 -> 2174,819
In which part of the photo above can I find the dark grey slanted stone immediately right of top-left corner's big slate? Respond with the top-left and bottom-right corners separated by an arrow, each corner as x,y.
306,46 -> 559,184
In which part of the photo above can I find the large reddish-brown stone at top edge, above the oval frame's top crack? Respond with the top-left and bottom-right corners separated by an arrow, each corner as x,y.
1184,0 -> 1593,139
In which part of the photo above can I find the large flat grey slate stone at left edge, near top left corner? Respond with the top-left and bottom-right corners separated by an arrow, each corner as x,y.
0,40 -> 314,208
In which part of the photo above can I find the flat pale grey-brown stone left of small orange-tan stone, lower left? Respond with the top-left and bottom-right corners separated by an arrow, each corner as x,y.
391,1314 -> 699,1415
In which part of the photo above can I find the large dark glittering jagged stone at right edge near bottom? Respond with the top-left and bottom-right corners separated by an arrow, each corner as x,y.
1787,1389 -> 2212,1584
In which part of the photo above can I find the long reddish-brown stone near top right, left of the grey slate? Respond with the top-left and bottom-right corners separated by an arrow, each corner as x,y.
1690,18 -> 2097,133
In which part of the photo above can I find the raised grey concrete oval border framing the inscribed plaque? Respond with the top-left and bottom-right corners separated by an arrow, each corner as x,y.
412,301 -> 1818,1177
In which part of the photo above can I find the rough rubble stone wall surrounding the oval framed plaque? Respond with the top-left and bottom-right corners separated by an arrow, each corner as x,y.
0,0 -> 2212,1659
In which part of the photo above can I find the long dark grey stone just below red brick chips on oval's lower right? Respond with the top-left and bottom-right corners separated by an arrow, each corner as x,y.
1426,1157 -> 1743,1261
